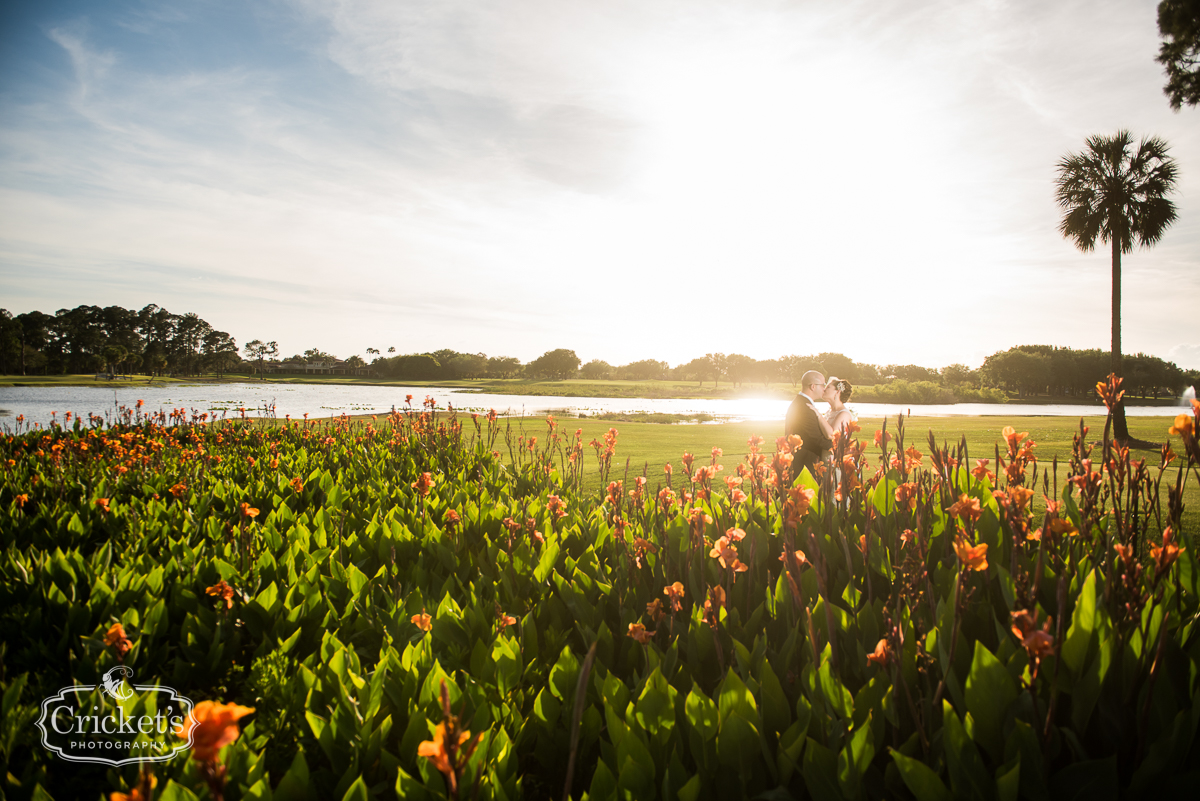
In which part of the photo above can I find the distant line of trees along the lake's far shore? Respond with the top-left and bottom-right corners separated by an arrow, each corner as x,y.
0,303 -> 1200,398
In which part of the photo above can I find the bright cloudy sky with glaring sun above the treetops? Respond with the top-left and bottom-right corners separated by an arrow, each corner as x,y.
0,0 -> 1200,368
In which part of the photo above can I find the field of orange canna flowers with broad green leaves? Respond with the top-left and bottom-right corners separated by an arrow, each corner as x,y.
0,380 -> 1200,801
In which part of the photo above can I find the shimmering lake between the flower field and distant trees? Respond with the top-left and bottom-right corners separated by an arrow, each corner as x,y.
0,383 -> 1176,429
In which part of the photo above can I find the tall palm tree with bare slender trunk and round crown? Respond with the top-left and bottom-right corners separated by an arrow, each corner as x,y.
1055,131 -> 1178,442
